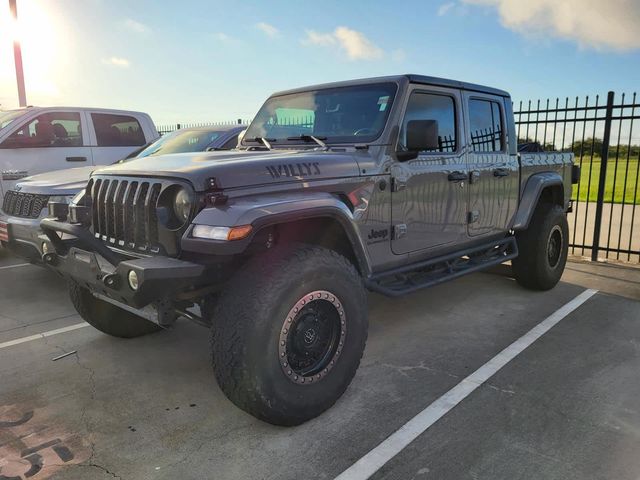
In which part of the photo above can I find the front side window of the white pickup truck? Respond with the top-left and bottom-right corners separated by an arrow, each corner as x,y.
2,112 -> 82,148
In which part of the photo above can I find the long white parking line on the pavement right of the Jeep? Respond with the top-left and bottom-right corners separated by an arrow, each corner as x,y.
336,290 -> 598,480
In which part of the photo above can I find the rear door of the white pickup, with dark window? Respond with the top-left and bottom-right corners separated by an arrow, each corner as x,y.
87,112 -> 147,165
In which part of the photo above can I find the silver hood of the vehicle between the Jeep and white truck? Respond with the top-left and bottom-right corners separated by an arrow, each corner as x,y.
13,166 -> 98,195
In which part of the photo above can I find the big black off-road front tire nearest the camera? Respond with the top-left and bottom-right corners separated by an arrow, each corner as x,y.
211,244 -> 368,426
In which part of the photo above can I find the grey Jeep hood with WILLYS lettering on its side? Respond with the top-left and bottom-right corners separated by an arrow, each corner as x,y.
92,150 -> 362,191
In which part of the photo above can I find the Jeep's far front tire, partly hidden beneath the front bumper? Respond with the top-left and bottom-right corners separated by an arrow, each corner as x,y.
69,282 -> 162,338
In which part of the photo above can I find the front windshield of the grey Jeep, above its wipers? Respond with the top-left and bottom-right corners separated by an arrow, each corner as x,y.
243,83 -> 396,144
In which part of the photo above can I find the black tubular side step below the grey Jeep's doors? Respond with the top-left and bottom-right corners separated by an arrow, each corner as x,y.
365,237 -> 518,297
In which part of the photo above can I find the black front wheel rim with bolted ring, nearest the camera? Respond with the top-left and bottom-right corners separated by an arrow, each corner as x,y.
278,290 -> 347,384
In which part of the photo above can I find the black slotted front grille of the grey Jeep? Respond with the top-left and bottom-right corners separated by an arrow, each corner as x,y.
88,178 -> 162,253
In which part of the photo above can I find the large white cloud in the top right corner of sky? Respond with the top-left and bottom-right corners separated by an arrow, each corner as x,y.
462,0 -> 640,50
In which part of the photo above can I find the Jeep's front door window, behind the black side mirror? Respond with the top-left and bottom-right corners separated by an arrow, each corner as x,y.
399,92 -> 458,153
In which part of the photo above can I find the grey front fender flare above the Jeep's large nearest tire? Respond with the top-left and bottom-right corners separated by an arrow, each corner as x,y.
182,192 -> 371,276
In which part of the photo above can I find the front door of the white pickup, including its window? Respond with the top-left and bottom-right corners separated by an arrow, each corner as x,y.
0,109 -> 92,192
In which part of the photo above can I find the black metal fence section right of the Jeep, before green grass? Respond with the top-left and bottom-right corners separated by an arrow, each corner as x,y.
514,92 -> 640,263
